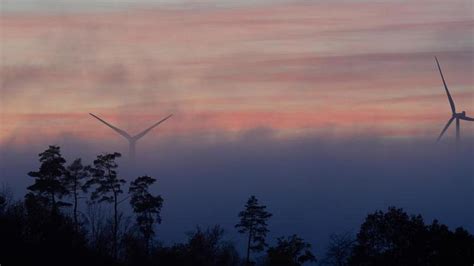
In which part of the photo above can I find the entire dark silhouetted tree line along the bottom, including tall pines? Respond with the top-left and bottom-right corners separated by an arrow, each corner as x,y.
0,146 -> 474,266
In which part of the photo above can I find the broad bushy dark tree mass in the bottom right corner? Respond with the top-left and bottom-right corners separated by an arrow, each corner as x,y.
349,207 -> 474,266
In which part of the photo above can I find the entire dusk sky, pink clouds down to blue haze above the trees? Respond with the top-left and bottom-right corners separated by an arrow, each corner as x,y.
0,0 -> 474,258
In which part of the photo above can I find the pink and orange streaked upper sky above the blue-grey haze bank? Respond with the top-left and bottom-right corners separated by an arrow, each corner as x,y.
0,0 -> 474,145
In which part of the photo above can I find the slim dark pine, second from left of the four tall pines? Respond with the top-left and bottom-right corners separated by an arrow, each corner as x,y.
63,158 -> 89,231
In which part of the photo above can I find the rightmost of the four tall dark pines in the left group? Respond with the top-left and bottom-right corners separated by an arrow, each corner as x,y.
128,176 -> 163,255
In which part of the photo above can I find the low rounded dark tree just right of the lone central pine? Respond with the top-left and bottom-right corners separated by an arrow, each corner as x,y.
267,235 -> 316,266
